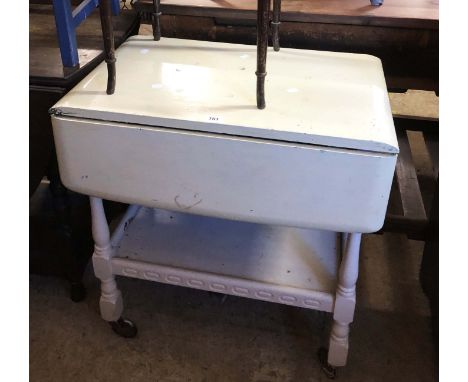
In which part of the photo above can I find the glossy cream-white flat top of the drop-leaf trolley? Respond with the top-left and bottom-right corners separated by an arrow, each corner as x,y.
54,36 -> 398,153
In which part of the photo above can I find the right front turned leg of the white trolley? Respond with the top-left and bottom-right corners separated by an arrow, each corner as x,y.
328,233 -> 361,367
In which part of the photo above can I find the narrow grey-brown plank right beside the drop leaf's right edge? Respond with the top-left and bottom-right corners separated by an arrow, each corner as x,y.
396,130 -> 427,220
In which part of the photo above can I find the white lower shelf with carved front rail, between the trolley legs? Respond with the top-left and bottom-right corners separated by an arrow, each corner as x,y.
112,208 -> 340,312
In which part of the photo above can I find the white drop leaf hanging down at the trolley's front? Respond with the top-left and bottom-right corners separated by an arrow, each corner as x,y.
52,117 -> 396,232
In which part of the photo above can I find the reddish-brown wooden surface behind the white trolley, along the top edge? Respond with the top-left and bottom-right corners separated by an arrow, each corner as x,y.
134,0 -> 439,29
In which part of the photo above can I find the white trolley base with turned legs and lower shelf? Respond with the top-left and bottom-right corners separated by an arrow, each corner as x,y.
100,204 -> 361,367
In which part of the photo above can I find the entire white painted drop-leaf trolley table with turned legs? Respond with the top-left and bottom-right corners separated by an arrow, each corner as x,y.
51,36 -> 398,376
